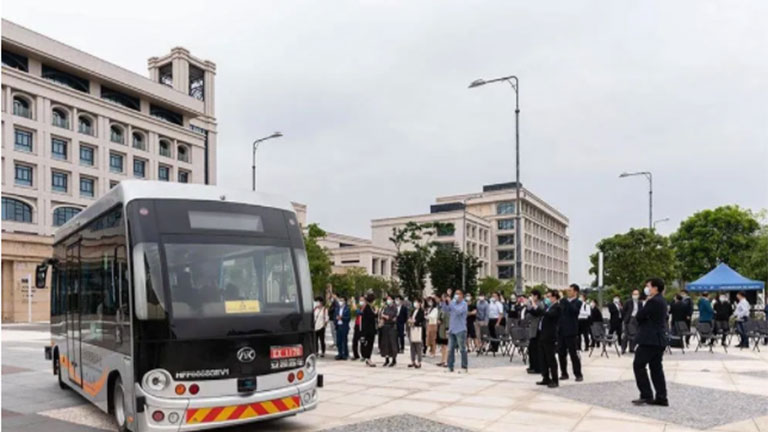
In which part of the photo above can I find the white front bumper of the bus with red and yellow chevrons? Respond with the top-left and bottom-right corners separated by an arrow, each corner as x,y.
136,375 -> 322,432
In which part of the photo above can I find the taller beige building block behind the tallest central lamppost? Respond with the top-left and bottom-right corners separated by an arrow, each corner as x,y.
433,182 -> 569,289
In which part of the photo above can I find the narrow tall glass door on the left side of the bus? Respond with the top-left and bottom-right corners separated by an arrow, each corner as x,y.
65,241 -> 83,387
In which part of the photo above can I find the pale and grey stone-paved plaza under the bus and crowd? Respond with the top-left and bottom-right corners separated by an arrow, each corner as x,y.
2,325 -> 768,432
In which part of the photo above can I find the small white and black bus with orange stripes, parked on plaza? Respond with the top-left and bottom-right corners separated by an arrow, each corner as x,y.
36,180 -> 323,432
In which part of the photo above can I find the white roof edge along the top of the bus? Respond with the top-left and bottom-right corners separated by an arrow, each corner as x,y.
53,180 -> 295,243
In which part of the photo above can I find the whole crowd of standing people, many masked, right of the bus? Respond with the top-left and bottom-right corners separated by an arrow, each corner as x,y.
314,279 -> 768,406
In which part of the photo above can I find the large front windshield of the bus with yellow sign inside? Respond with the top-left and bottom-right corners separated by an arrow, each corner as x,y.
143,242 -> 301,319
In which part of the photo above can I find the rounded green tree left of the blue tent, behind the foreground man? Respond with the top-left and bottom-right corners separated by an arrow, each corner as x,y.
589,228 -> 678,297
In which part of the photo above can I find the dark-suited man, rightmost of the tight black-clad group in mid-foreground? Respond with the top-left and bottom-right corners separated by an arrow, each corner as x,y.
558,284 -> 584,382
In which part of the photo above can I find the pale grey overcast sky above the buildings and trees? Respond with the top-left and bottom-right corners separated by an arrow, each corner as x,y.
2,0 -> 768,282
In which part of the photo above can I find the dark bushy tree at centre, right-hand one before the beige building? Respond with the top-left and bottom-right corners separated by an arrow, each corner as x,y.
427,246 -> 480,295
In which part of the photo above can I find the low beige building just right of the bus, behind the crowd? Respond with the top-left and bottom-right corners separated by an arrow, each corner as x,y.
318,232 -> 396,278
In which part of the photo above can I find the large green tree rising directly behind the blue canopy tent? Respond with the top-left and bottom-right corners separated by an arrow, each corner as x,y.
670,205 -> 760,281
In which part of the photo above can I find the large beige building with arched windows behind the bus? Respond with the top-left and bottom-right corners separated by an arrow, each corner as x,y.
2,20 -> 217,322
